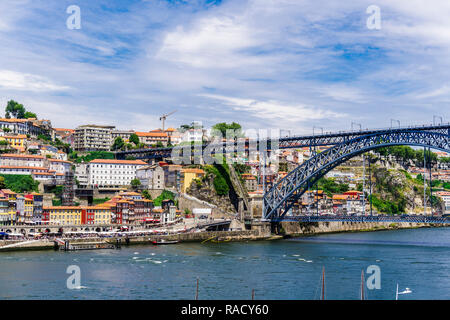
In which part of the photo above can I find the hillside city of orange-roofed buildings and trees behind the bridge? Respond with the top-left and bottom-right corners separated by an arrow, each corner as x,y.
0,100 -> 450,232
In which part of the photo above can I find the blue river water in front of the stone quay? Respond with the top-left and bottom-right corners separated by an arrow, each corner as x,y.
0,228 -> 450,300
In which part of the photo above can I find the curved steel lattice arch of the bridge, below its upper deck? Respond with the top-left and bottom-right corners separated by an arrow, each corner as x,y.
263,130 -> 450,220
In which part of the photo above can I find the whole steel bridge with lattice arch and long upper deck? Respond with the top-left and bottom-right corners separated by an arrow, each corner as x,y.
116,124 -> 450,221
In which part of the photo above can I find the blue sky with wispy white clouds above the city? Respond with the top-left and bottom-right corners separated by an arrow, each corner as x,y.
0,0 -> 450,134
